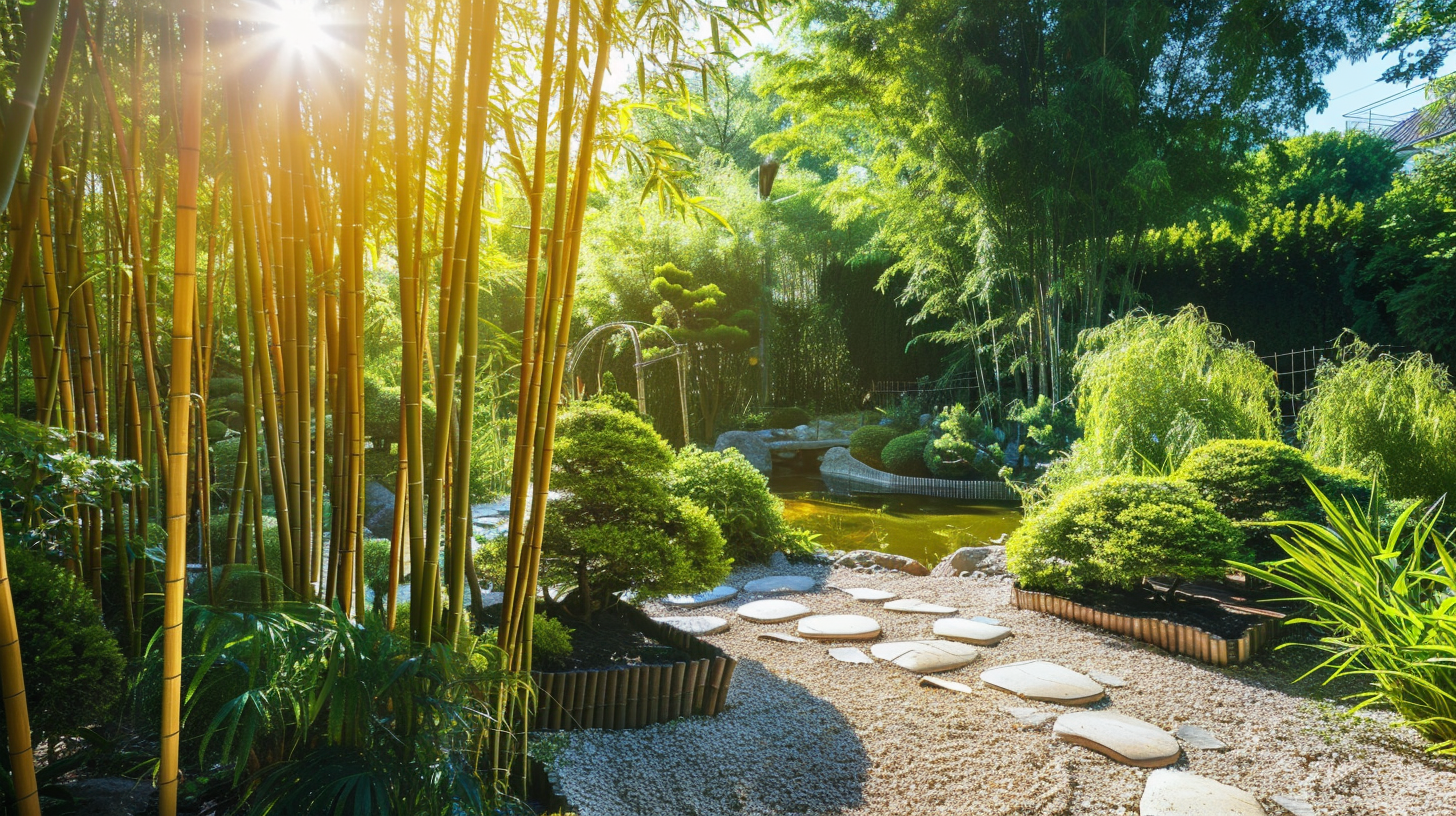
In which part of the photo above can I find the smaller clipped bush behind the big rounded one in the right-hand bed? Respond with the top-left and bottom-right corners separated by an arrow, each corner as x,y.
1175,439 -> 1318,522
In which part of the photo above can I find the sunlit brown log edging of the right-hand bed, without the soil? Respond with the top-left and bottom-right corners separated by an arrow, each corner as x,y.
1010,586 -> 1278,666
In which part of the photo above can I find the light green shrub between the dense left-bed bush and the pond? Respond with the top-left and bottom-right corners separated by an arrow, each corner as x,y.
668,444 -> 811,561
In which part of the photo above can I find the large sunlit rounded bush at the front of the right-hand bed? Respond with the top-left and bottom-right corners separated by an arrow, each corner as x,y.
1006,476 -> 1245,592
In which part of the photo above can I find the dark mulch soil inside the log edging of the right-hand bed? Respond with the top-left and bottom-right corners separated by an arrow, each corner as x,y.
1063,586 -> 1289,640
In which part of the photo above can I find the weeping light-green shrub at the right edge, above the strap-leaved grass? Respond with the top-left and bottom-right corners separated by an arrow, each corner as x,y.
1297,341 -> 1456,500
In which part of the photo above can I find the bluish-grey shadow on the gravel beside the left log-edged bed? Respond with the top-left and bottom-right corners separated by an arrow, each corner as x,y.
553,660 -> 869,816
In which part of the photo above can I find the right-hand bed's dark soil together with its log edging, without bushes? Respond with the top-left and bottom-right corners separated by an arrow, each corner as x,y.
1012,586 -> 1284,666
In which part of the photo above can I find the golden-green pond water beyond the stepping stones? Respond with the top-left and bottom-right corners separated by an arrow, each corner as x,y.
769,475 -> 1021,567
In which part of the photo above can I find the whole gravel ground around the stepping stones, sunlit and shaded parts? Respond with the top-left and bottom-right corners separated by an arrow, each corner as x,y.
555,564 -> 1456,816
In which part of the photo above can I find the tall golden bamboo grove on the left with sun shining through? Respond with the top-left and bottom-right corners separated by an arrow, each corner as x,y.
0,0 -> 766,815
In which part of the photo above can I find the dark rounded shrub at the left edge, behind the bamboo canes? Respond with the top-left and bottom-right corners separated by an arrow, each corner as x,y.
0,546 -> 127,740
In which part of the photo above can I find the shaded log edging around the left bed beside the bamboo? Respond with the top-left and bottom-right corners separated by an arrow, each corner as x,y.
531,605 -> 738,731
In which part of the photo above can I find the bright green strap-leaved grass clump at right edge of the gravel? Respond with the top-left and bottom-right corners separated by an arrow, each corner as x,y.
1239,488 -> 1456,753
